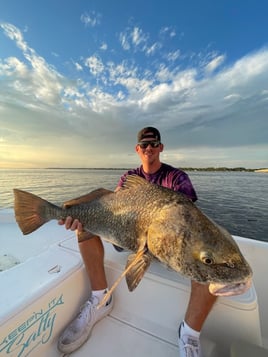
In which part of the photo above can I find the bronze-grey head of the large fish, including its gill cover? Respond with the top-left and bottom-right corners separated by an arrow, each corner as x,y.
147,207 -> 252,295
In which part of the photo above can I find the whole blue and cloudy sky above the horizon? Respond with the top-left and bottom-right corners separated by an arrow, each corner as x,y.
0,0 -> 268,168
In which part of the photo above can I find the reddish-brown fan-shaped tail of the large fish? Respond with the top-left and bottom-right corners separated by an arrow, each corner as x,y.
13,189 -> 60,234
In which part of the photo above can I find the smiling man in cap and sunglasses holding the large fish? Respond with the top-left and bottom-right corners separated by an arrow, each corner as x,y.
58,127 -> 216,357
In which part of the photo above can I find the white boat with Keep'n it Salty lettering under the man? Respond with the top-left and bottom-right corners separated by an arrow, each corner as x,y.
0,209 -> 268,357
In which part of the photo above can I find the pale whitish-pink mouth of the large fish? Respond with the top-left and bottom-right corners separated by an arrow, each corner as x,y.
209,279 -> 252,296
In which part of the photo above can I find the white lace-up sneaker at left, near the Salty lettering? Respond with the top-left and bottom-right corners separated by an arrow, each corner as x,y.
58,296 -> 113,353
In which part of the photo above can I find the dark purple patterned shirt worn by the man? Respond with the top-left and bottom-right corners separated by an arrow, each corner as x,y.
117,163 -> 197,202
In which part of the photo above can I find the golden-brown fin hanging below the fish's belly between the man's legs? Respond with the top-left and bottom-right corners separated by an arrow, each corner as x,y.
126,252 -> 153,291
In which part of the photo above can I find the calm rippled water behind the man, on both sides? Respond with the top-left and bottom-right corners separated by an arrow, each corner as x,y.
0,169 -> 268,241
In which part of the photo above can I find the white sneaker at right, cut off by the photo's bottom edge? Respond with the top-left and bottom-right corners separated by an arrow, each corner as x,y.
179,322 -> 202,357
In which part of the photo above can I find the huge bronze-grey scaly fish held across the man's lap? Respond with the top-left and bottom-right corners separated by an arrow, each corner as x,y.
14,175 -> 252,296
